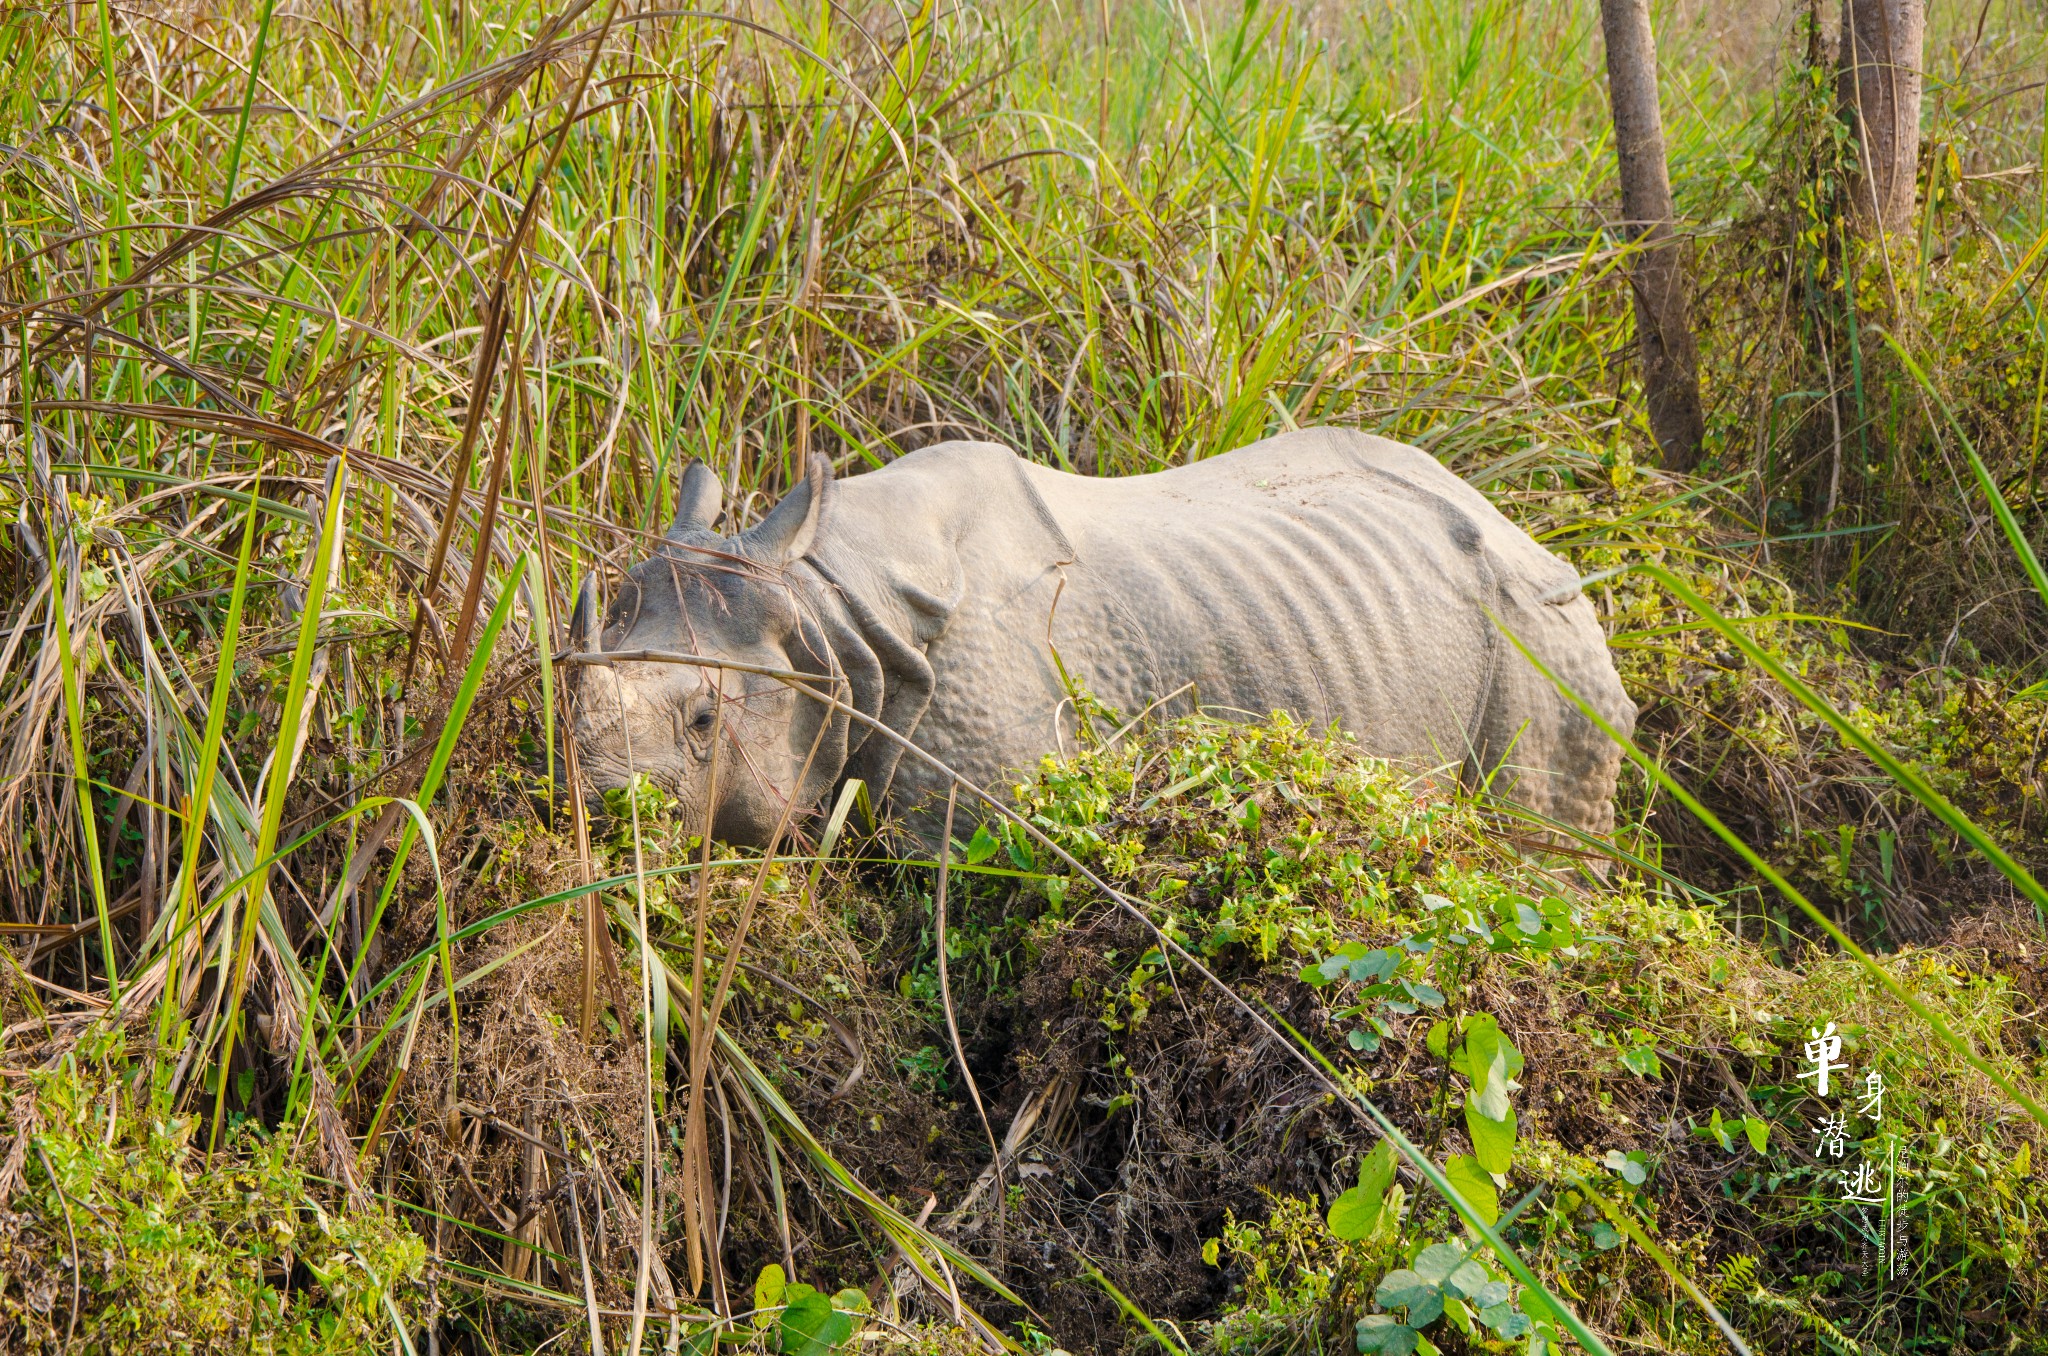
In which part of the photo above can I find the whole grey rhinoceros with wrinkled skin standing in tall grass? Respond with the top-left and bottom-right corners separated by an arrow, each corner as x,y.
571,428 -> 1634,844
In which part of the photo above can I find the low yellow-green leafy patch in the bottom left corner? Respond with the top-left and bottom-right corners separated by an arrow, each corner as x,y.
0,1049 -> 426,1352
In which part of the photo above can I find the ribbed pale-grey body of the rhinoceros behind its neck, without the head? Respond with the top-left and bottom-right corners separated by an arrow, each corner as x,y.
815,428 -> 1632,830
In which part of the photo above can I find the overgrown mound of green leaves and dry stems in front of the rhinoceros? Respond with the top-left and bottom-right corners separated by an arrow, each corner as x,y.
966,719 -> 2048,1352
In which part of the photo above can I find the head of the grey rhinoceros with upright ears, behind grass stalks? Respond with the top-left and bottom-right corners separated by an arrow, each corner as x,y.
569,457 -> 844,844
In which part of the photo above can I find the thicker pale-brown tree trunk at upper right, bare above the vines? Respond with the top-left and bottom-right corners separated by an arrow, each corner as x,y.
1837,0 -> 1927,236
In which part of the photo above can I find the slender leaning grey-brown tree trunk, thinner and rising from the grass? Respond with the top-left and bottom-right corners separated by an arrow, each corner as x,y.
1599,0 -> 1706,471
